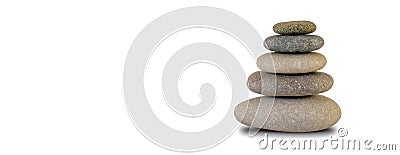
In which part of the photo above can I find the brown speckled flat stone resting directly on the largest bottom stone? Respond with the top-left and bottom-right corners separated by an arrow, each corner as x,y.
247,71 -> 333,96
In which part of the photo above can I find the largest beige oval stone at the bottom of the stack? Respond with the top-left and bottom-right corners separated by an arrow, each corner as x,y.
234,95 -> 341,132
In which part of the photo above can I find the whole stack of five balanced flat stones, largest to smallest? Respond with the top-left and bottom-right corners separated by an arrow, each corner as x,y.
235,21 -> 341,132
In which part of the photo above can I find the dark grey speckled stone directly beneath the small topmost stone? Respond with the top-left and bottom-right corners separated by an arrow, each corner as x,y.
264,35 -> 324,52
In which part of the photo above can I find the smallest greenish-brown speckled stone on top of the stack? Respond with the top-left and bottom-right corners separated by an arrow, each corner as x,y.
273,21 -> 317,35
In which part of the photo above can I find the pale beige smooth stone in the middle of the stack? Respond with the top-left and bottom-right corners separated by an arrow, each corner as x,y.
257,52 -> 326,74
